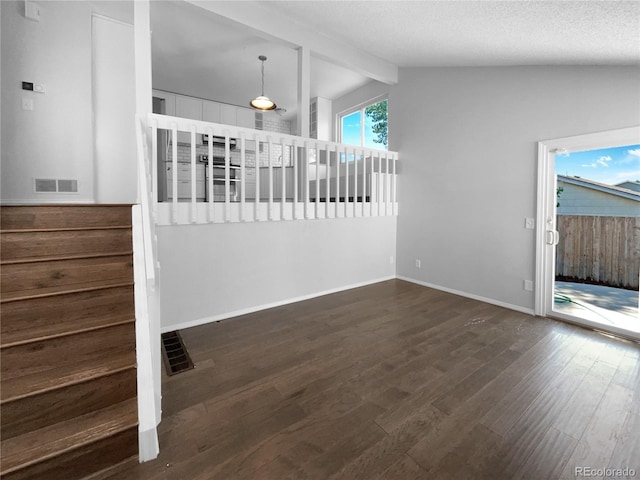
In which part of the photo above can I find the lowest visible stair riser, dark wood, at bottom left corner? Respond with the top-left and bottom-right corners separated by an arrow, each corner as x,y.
2,427 -> 138,480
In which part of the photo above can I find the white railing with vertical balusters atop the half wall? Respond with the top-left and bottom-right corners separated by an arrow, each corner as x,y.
147,114 -> 398,225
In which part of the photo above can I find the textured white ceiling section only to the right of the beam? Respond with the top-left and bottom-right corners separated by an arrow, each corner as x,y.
269,0 -> 640,67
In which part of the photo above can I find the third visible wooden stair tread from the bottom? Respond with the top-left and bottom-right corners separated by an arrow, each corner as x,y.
0,315 -> 135,349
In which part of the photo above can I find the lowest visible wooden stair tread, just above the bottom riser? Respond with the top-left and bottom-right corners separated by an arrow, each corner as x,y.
1,398 -> 138,475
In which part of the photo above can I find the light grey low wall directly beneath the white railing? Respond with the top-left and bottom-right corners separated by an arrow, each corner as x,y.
157,217 -> 396,331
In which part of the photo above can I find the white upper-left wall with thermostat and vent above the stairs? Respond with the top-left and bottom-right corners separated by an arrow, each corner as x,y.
0,1 -> 133,203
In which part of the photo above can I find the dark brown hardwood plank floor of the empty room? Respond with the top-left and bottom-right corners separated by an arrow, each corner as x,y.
112,280 -> 640,480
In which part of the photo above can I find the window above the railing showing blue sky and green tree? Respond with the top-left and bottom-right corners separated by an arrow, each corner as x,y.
340,99 -> 387,150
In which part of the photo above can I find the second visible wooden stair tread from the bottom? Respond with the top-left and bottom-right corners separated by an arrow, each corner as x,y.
0,351 -> 136,405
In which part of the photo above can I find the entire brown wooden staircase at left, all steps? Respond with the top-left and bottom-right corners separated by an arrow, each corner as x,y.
0,205 -> 138,480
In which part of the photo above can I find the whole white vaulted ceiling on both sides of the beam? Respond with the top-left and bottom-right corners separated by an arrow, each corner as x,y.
151,0 -> 640,124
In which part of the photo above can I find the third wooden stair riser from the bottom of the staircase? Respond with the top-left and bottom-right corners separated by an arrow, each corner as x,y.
0,323 -> 135,386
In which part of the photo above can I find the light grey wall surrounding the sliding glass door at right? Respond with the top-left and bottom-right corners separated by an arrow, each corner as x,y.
389,67 -> 640,310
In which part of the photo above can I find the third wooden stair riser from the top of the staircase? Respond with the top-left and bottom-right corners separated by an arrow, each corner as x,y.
0,255 -> 133,294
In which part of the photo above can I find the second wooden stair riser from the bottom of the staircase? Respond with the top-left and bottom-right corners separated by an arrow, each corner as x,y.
0,367 -> 137,440
